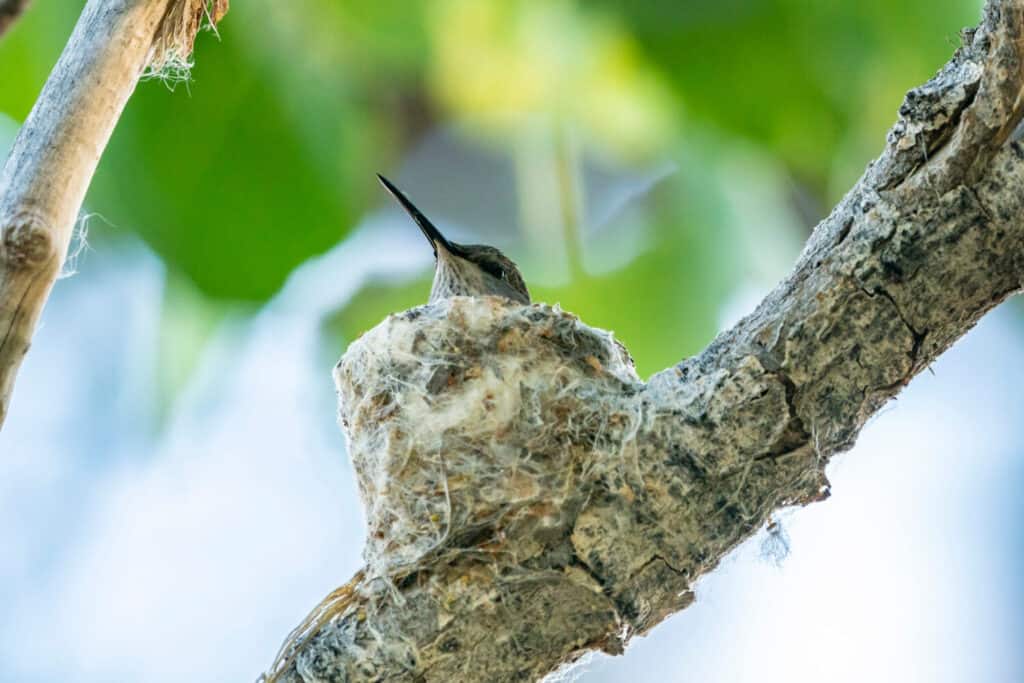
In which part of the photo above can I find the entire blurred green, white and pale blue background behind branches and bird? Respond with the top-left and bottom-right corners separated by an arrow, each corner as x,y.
0,0 -> 1024,683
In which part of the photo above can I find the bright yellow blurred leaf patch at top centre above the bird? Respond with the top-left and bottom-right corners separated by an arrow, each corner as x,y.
429,0 -> 679,158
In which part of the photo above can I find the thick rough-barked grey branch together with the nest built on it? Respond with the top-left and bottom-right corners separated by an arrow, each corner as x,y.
267,0 -> 1024,683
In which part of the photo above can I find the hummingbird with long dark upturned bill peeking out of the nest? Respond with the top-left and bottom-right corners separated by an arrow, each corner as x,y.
377,173 -> 529,304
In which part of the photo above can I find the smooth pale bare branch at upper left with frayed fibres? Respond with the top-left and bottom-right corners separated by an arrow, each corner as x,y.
0,0 -> 227,427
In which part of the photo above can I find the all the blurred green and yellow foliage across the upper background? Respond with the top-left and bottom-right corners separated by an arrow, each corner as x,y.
0,0 -> 981,385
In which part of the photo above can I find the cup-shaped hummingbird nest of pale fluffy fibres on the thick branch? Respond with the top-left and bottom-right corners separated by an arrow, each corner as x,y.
334,296 -> 643,583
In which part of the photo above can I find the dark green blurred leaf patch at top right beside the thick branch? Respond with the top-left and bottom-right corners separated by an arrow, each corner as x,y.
596,0 -> 982,192
